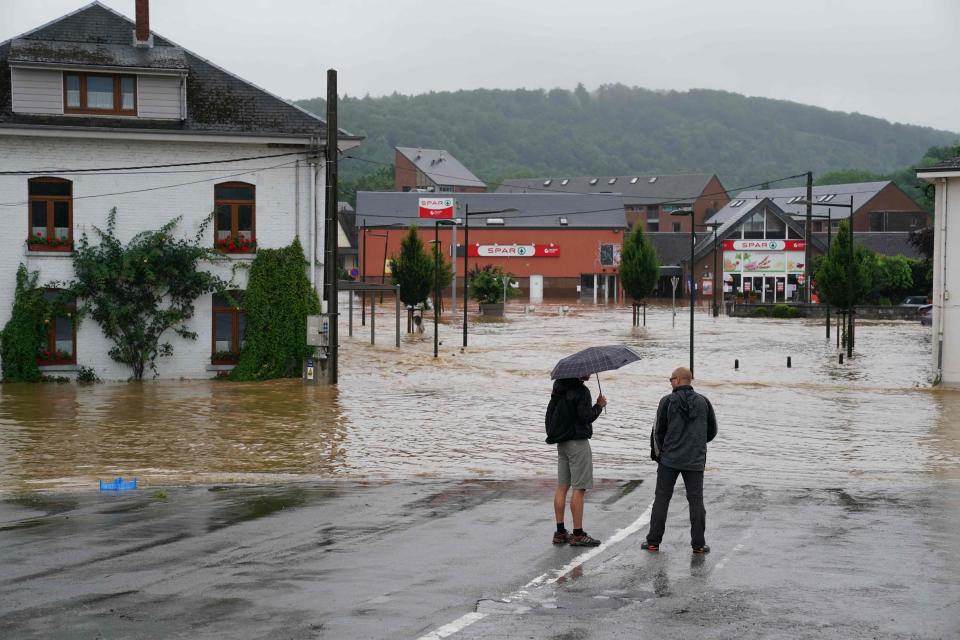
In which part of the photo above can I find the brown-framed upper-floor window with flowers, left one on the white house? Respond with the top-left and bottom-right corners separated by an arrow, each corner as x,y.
27,178 -> 73,251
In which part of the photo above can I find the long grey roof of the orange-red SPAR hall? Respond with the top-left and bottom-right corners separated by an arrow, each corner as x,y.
356,191 -> 626,229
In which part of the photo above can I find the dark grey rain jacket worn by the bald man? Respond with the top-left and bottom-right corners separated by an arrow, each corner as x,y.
650,385 -> 717,471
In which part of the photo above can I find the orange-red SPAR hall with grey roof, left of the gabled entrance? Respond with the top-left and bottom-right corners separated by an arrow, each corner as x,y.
356,191 -> 626,301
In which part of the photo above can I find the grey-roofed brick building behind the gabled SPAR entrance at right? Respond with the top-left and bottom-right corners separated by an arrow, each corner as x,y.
711,180 -> 930,232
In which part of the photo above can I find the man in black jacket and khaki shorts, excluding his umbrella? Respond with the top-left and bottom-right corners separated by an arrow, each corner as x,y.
553,376 -> 607,547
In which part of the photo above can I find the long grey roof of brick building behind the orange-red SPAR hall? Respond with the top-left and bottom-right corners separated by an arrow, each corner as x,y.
497,173 -> 722,205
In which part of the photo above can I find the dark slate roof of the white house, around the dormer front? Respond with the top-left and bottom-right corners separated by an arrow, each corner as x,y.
0,2 -> 356,139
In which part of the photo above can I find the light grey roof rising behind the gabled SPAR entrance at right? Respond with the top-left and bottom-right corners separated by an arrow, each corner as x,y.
710,180 -> 908,222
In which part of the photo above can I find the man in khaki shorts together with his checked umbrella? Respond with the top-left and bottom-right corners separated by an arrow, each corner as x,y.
547,345 -> 640,547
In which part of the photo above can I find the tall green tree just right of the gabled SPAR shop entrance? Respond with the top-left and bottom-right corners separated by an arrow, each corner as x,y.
814,220 -> 874,310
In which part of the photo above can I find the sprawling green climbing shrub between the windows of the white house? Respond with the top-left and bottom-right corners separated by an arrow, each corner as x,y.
70,208 -> 224,380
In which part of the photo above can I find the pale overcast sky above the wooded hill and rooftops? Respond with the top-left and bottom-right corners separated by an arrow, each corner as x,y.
0,0 -> 960,132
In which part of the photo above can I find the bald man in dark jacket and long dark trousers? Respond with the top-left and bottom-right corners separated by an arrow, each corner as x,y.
643,367 -> 717,554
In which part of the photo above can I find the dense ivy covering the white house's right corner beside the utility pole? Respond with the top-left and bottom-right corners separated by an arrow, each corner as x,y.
230,240 -> 320,380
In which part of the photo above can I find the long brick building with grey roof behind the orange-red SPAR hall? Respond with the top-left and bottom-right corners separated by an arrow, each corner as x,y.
497,173 -> 730,233
